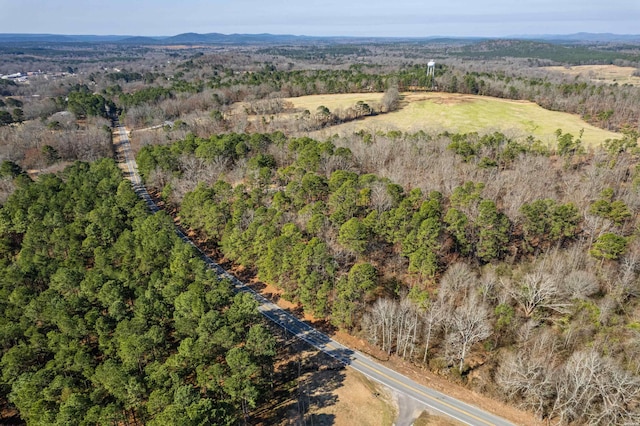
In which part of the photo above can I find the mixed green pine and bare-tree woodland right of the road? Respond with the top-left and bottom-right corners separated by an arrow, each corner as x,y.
138,125 -> 640,424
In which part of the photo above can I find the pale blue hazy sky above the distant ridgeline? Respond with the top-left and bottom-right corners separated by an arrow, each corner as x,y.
0,0 -> 640,37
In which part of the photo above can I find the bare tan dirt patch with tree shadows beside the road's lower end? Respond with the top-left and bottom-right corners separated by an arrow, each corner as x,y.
248,325 -> 396,426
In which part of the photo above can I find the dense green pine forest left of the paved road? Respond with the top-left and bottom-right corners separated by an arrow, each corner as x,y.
0,160 -> 275,425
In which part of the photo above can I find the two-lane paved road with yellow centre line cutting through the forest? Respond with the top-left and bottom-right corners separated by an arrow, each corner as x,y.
118,126 -> 511,425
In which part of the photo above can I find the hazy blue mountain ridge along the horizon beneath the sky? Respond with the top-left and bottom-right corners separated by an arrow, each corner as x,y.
0,32 -> 640,45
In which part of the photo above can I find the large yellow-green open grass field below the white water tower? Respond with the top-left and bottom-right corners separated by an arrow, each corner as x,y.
287,93 -> 621,146
